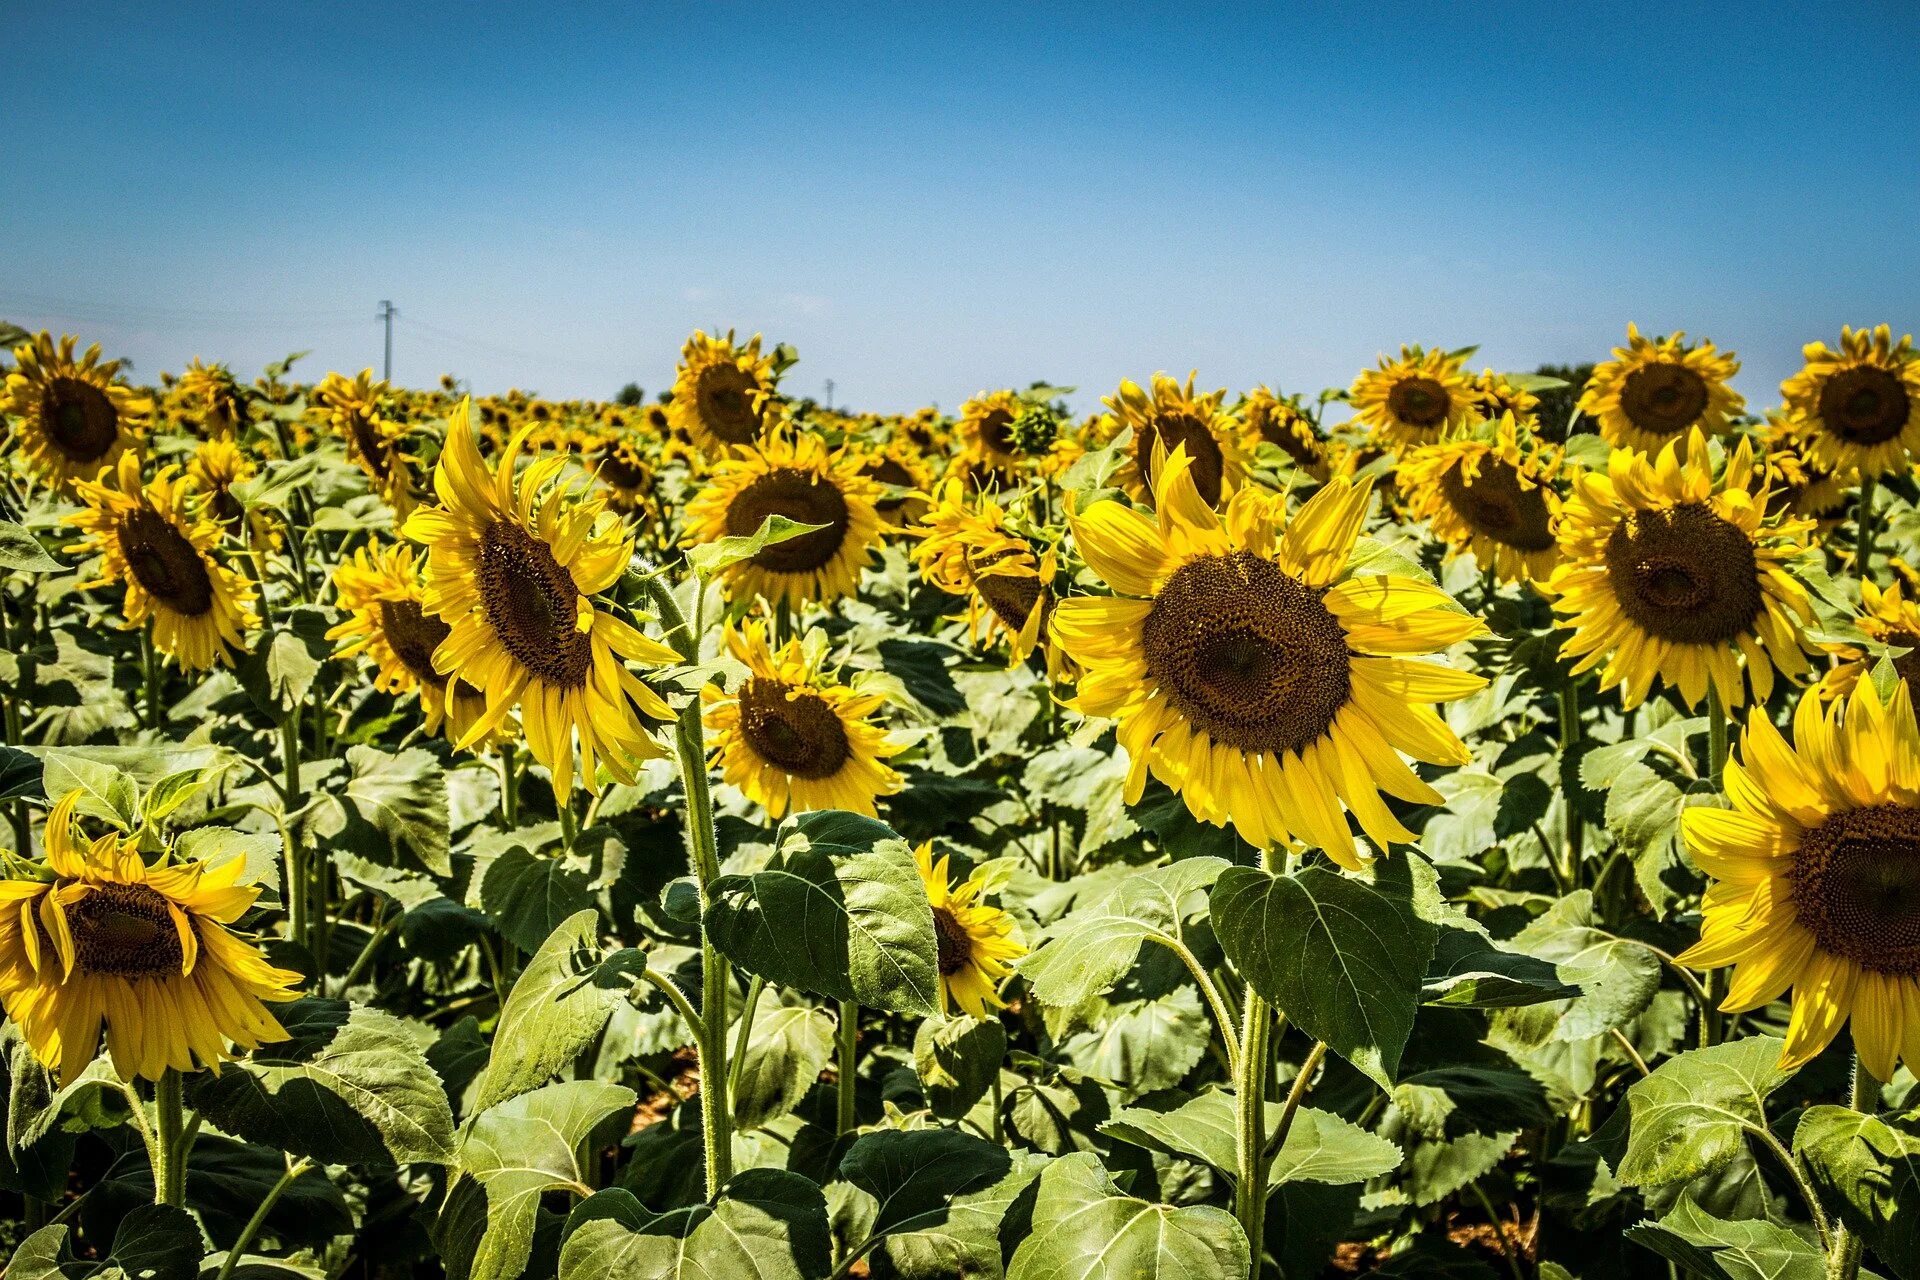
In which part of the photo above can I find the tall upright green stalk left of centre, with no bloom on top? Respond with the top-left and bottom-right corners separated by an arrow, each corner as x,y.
645,576 -> 733,1199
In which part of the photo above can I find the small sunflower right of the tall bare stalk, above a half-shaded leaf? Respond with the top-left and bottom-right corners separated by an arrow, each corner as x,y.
701,620 -> 902,818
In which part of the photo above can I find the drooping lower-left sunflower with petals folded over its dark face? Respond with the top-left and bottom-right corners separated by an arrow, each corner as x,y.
0,791 -> 301,1086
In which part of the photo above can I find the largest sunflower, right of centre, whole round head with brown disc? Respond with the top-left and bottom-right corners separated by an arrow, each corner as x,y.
1052,449 -> 1486,867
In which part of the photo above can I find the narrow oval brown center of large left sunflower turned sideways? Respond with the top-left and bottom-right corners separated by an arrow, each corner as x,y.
476,520 -> 593,689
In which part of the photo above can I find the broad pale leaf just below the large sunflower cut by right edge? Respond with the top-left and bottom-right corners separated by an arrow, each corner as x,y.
1615,1036 -> 1793,1186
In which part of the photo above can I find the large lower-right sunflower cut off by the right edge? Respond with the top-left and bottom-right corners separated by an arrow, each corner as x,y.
1678,679 -> 1920,1080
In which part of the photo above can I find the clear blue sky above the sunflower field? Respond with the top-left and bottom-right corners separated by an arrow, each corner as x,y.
0,2 -> 1920,411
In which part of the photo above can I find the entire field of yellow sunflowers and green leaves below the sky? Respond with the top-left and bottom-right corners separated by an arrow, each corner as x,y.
0,326 -> 1920,1280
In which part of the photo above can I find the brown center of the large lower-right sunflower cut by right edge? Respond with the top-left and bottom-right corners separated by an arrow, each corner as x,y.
1788,804 -> 1920,977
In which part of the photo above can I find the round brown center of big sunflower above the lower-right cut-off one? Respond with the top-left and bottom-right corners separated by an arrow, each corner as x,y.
1607,503 -> 1764,645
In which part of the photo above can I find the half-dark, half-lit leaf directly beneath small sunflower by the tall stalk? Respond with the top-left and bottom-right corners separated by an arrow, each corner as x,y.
707,810 -> 939,1013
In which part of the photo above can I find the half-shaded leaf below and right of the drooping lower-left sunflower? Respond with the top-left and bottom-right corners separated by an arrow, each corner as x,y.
192,998 -> 453,1165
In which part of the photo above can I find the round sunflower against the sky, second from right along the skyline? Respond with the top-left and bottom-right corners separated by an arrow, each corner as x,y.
1580,324 -> 1747,453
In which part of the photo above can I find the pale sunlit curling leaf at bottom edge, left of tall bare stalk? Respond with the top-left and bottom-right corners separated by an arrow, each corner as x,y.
440,1080 -> 634,1280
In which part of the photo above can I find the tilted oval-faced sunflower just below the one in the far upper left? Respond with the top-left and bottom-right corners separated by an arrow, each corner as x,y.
65,453 -> 253,672
